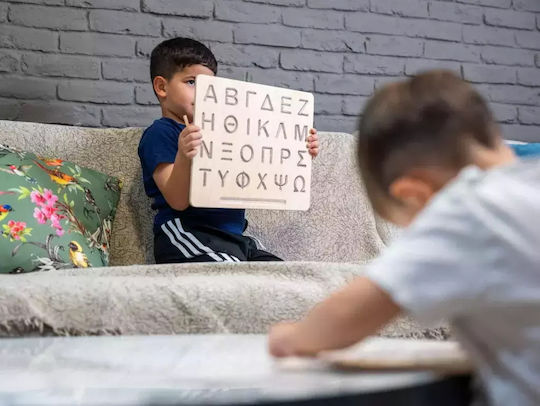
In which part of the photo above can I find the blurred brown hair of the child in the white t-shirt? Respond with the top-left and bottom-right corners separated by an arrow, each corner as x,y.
358,70 -> 498,213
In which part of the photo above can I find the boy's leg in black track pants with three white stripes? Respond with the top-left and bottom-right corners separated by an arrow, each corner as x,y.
154,219 -> 247,264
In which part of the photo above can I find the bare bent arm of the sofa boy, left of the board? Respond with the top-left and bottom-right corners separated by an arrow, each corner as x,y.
153,124 -> 202,210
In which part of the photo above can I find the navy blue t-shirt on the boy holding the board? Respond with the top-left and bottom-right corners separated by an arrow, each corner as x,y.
139,117 -> 246,234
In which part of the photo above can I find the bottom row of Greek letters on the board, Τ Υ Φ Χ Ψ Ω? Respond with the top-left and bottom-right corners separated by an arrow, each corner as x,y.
199,168 -> 306,193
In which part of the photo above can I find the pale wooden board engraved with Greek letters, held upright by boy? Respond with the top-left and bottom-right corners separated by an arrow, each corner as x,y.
190,75 -> 314,210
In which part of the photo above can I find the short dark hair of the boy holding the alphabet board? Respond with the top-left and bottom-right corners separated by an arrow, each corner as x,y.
150,37 -> 217,82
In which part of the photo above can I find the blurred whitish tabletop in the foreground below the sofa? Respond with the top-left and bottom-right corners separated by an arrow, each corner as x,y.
0,335 -> 468,405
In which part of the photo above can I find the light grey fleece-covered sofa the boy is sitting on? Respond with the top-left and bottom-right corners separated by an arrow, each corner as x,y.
0,121 -> 446,338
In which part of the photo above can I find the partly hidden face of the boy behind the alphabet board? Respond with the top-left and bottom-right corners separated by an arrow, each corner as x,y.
154,65 -> 214,123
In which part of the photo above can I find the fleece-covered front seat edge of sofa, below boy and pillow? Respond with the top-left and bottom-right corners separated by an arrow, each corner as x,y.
0,262 -> 446,338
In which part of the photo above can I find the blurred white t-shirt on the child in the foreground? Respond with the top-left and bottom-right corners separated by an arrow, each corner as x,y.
367,161 -> 540,406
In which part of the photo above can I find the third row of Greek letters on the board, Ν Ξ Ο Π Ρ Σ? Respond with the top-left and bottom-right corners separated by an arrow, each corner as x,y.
199,140 -> 309,168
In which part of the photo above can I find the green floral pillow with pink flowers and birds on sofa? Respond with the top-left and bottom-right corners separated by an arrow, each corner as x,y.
0,144 -> 121,273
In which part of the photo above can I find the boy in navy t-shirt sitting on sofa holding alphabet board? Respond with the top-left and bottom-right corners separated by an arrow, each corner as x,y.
138,38 -> 319,263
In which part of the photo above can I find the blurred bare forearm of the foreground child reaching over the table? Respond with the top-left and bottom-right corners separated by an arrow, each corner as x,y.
269,277 -> 401,357
